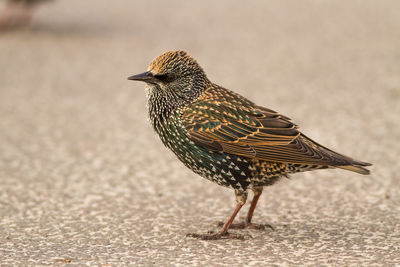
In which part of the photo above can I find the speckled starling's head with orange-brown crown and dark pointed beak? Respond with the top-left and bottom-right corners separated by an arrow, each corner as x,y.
128,51 -> 208,100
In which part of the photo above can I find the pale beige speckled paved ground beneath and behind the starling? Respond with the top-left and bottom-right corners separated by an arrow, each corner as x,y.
0,0 -> 400,266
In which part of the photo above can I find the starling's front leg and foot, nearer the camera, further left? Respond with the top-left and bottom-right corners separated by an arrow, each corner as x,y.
187,190 -> 247,240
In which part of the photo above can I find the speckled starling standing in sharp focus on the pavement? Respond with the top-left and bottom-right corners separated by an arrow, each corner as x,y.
128,51 -> 372,240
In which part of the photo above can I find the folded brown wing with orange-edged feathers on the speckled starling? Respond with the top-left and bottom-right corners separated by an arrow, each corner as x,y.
181,86 -> 368,166
